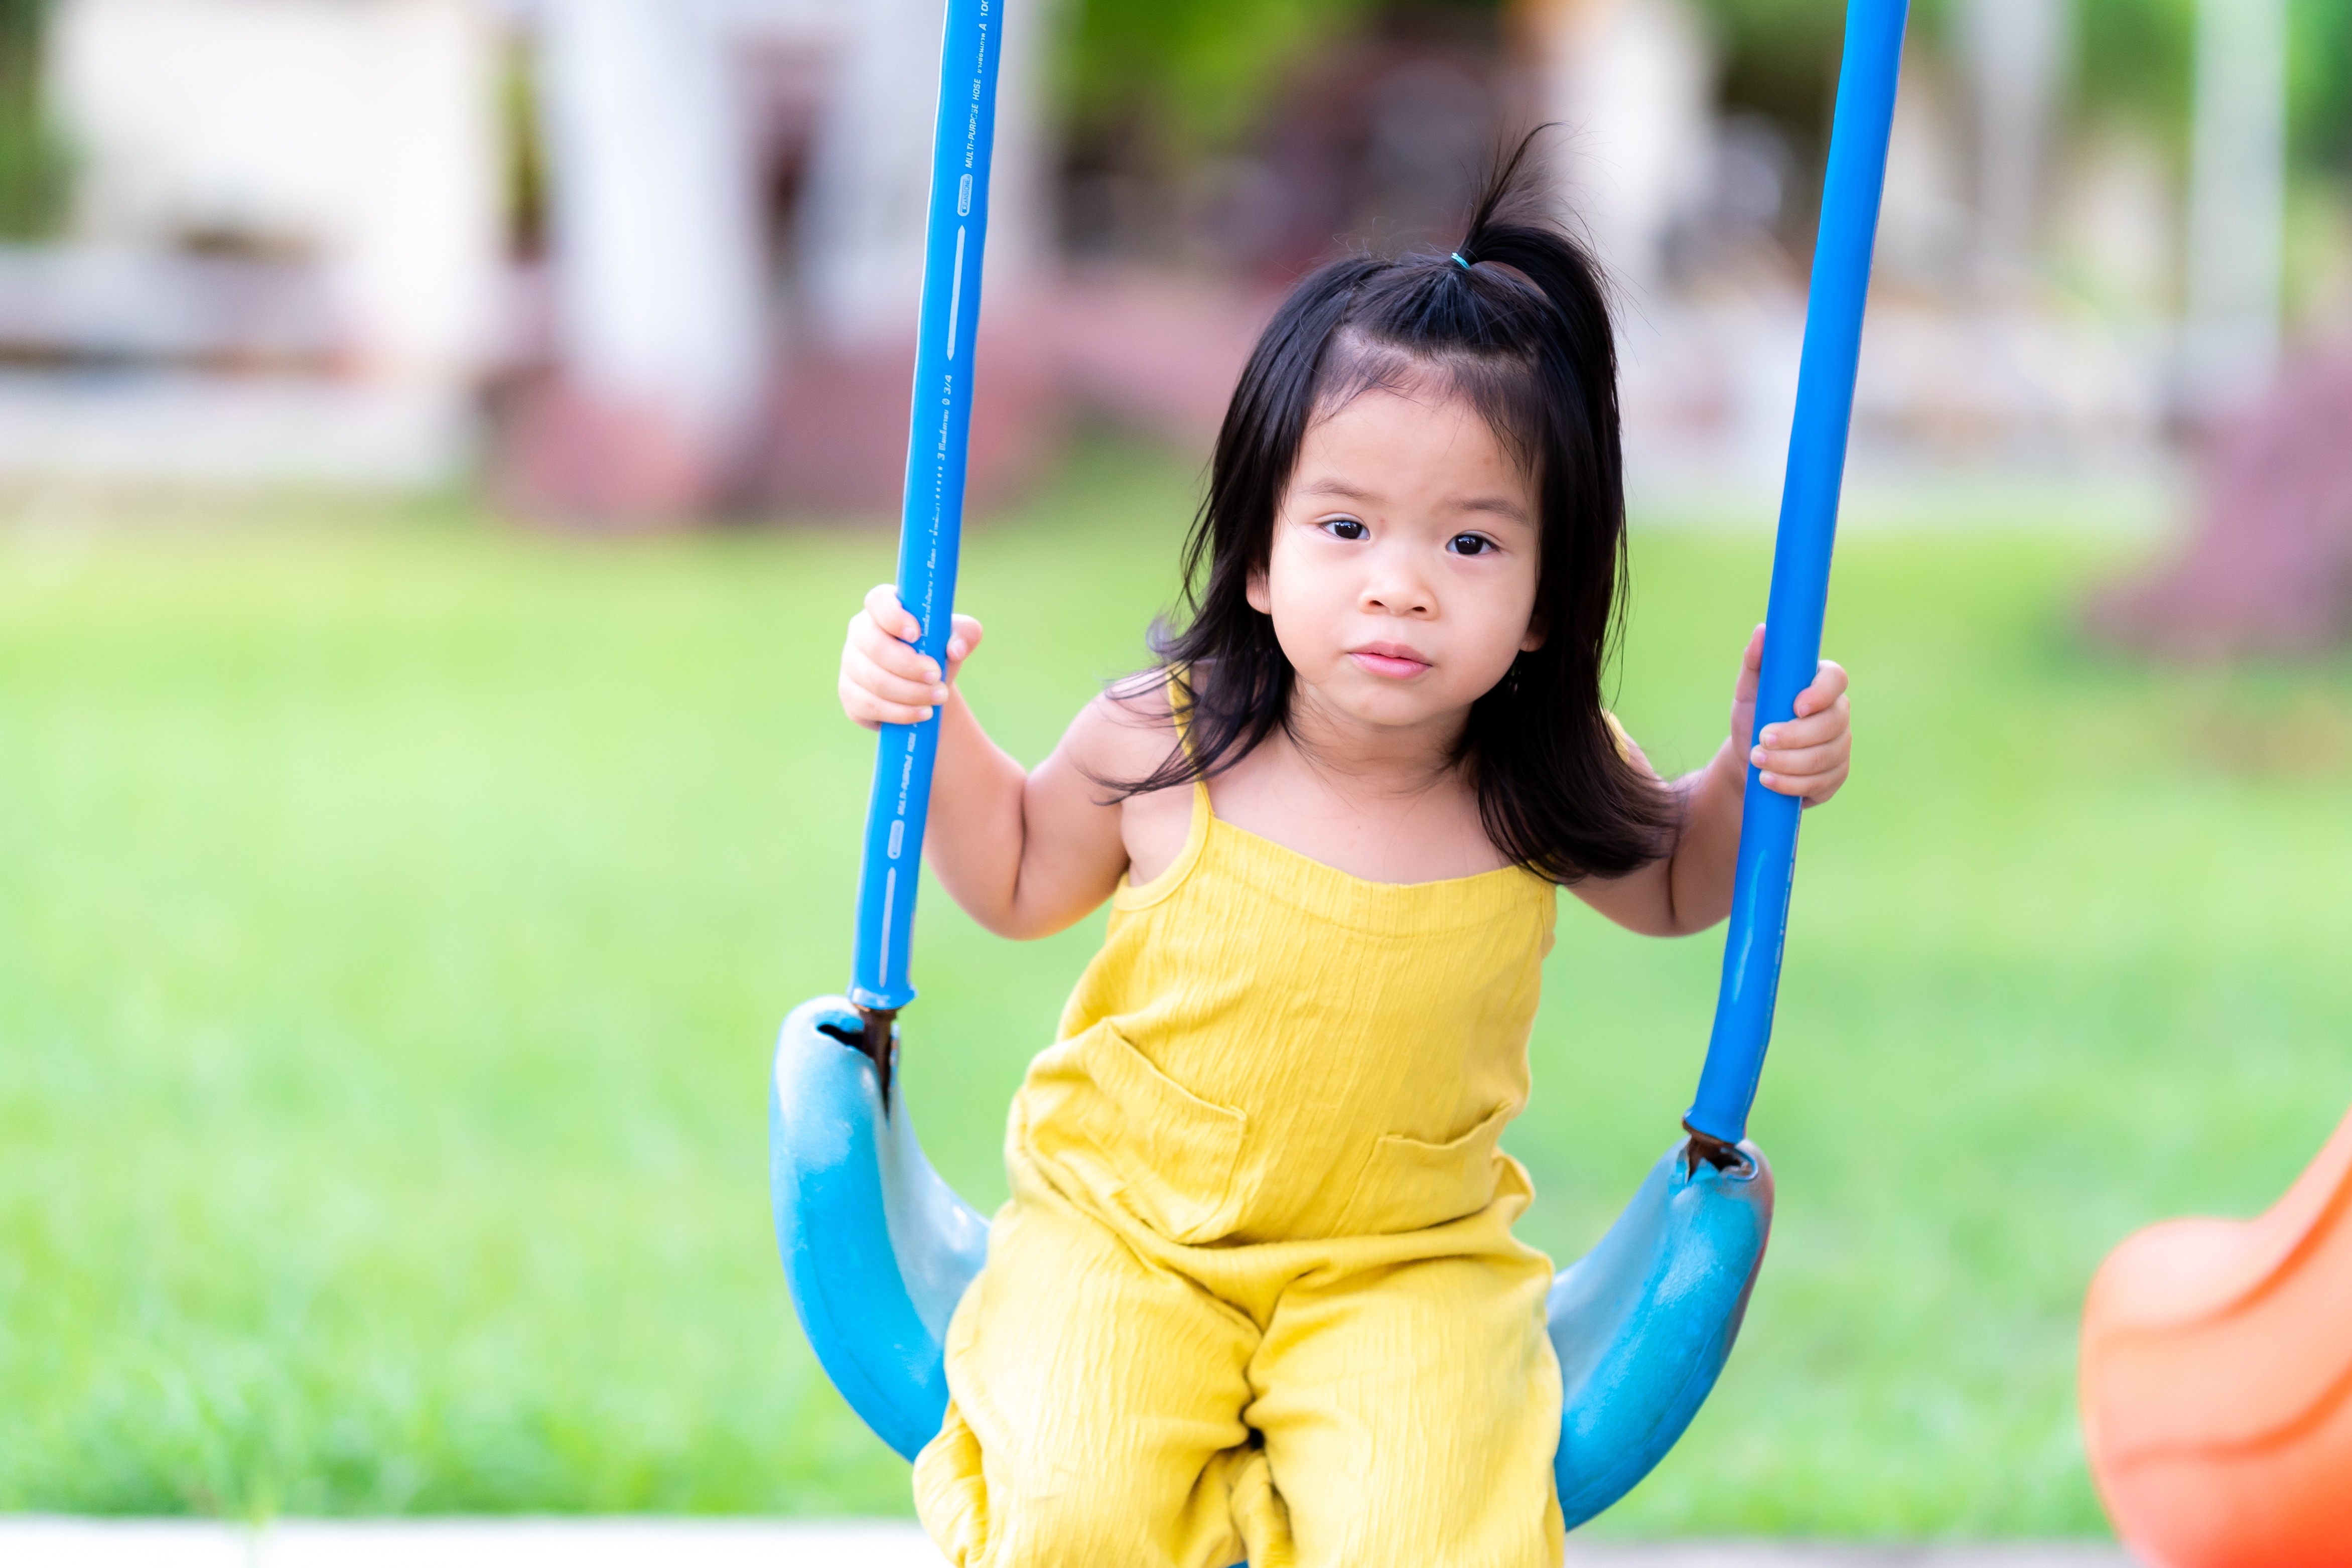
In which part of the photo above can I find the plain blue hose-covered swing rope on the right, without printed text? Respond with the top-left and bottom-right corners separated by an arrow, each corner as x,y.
1684,0 -> 1910,1145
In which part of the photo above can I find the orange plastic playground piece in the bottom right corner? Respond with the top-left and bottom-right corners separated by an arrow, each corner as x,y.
2082,1116 -> 2352,1568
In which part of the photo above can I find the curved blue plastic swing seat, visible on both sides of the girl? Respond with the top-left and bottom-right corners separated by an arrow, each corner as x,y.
769,997 -> 1771,1528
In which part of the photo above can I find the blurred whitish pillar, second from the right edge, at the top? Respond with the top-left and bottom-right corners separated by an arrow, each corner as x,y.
1959,0 -> 2070,287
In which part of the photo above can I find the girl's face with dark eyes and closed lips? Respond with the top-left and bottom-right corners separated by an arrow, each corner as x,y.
1249,385 -> 1543,747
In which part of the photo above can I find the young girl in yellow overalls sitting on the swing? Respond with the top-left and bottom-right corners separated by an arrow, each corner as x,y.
842,148 -> 1849,1568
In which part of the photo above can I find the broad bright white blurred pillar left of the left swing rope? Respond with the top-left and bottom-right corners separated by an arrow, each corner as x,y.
541,0 -> 767,444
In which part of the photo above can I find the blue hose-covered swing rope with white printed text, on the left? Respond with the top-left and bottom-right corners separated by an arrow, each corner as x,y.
849,0 -> 1004,1013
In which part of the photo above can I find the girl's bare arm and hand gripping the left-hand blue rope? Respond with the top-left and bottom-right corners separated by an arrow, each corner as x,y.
840,583 -> 1143,938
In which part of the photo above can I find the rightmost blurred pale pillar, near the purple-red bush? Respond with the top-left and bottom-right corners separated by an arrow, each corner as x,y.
2183,0 -> 2286,414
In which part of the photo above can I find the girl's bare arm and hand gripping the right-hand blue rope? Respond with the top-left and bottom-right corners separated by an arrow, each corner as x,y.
1576,625 -> 1853,936
